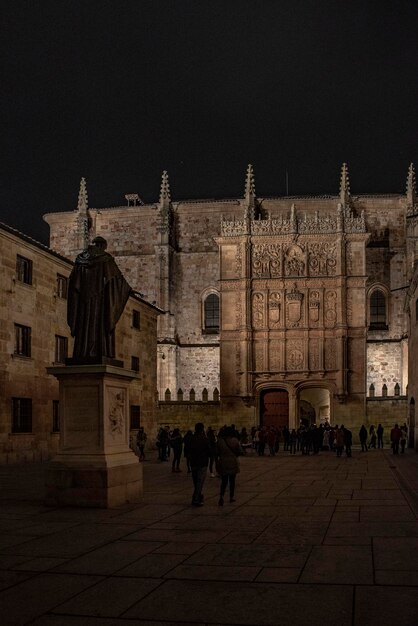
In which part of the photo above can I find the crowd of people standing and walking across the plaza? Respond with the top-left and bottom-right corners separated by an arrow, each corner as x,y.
130,422 -> 408,506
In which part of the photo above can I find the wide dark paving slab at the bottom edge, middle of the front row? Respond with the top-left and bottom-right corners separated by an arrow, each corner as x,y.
124,580 -> 353,626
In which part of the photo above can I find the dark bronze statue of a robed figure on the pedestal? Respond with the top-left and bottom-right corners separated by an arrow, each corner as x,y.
67,237 -> 132,364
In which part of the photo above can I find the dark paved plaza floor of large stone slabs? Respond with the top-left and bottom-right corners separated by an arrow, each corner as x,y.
0,450 -> 418,626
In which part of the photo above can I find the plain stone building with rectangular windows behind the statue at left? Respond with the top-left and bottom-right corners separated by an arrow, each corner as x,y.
0,224 -> 159,464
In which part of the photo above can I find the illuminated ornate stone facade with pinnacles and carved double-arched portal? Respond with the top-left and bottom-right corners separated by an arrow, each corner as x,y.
45,164 -> 418,436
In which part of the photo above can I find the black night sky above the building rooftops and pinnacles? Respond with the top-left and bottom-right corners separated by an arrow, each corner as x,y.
0,0 -> 418,242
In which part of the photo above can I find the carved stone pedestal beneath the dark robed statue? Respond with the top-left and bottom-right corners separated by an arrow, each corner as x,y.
46,364 -> 142,507
